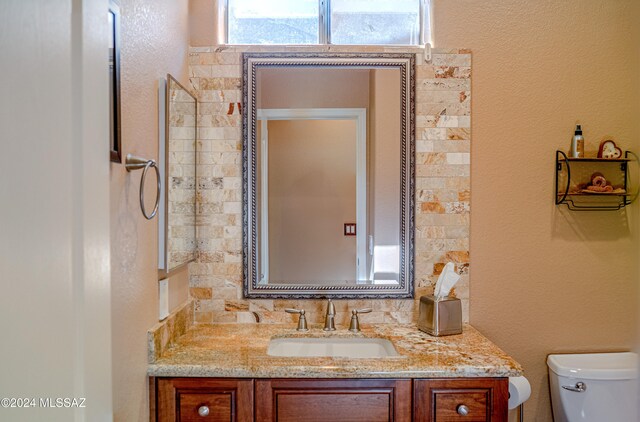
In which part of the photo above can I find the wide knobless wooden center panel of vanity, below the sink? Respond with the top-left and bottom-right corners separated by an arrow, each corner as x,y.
256,379 -> 411,422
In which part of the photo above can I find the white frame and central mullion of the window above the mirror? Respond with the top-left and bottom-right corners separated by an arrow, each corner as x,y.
217,0 -> 433,47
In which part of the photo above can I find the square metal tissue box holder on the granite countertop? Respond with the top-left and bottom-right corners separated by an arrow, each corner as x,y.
418,296 -> 462,336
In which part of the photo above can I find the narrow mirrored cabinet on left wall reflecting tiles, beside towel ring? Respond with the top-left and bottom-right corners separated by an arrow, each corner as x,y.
158,75 -> 197,276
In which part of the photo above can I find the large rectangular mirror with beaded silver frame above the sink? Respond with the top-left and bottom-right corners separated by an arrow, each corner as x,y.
245,55 -> 412,297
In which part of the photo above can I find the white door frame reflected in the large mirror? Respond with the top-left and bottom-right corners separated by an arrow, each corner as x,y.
256,108 -> 367,282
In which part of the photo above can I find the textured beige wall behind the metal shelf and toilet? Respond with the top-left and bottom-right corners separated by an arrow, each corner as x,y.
434,0 -> 640,421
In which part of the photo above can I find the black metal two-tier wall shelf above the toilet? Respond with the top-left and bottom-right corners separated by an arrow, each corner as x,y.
555,151 -> 640,211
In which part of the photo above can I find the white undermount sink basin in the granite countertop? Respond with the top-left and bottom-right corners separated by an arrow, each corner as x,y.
267,337 -> 400,358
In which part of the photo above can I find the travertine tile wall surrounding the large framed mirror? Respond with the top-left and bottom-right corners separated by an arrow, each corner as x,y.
189,46 -> 471,325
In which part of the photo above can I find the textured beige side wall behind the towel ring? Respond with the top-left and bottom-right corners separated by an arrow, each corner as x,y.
111,0 -> 188,421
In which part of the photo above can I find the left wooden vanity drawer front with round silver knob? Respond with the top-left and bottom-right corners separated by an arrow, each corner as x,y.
151,378 -> 253,422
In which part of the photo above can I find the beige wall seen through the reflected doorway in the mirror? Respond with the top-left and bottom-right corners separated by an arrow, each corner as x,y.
269,120 -> 356,281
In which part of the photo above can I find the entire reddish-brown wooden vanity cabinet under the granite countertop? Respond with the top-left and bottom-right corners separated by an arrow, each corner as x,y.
149,378 -> 509,422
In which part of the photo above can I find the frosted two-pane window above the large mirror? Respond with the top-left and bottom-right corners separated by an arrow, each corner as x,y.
221,0 -> 430,45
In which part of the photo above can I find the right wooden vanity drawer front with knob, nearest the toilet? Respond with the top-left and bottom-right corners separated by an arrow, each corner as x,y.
413,378 -> 509,422
